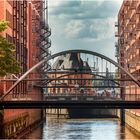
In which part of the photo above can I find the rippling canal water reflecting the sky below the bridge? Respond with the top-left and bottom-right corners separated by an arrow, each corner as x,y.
25,118 -> 140,140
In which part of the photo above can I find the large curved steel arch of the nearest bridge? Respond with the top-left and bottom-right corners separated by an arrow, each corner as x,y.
0,49 -> 140,100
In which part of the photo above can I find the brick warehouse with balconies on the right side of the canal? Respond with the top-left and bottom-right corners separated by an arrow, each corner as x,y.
116,0 -> 140,135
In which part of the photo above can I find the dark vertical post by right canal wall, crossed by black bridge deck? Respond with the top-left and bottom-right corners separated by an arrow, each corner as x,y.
120,87 -> 125,126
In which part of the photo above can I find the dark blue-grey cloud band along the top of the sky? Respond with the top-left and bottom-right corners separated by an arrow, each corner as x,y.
49,0 -> 119,19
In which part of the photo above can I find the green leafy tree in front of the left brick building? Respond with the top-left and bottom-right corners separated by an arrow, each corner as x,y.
0,21 -> 20,76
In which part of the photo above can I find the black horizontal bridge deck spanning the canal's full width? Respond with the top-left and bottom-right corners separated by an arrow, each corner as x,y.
0,100 -> 140,109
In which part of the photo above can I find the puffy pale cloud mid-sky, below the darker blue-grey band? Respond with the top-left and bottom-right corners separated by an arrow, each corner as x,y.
64,18 -> 115,41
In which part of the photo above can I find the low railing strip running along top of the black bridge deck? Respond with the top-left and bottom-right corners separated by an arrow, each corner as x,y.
5,92 -> 140,101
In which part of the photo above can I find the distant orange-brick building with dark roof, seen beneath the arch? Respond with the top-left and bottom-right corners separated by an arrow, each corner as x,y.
48,53 -> 93,94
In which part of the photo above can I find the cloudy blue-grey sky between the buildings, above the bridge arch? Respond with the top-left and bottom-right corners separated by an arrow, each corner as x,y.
48,0 -> 122,59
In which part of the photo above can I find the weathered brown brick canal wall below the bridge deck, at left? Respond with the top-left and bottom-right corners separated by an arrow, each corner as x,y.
1,109 -> 43,138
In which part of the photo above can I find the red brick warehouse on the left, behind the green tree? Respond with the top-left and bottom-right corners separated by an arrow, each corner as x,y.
0,0 -> 47,138
